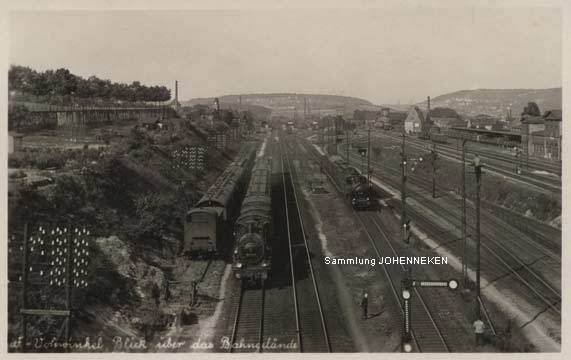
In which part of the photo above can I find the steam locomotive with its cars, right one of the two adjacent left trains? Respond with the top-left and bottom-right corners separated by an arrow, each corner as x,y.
232,150 -> 272,284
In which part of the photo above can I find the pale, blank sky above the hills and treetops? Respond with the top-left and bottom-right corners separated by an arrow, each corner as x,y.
9,7 -> 561,104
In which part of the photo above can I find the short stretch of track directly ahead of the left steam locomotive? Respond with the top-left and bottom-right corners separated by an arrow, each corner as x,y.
229,282 -> 265,353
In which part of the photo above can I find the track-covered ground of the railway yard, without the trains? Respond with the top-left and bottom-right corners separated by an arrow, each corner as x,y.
149,126 -> 561,352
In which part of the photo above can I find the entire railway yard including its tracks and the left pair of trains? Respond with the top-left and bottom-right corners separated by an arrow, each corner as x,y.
8,119 -> 561,353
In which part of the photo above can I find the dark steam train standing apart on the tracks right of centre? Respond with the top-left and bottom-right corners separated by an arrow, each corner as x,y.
323,158 -> 375,210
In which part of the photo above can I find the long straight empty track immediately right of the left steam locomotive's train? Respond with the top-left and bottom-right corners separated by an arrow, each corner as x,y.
281,140 -> 332,352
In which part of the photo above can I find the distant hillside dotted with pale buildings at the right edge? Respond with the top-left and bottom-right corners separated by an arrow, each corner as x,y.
418,88 -> 562,117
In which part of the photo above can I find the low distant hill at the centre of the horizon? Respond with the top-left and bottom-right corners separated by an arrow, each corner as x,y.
183,93 -> 377,117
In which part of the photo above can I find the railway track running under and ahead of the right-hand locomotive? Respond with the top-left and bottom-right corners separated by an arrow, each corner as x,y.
303,137 -> 450,352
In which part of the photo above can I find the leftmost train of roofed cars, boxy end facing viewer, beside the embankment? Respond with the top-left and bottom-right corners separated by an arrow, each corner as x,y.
183,149 -> 255,257
